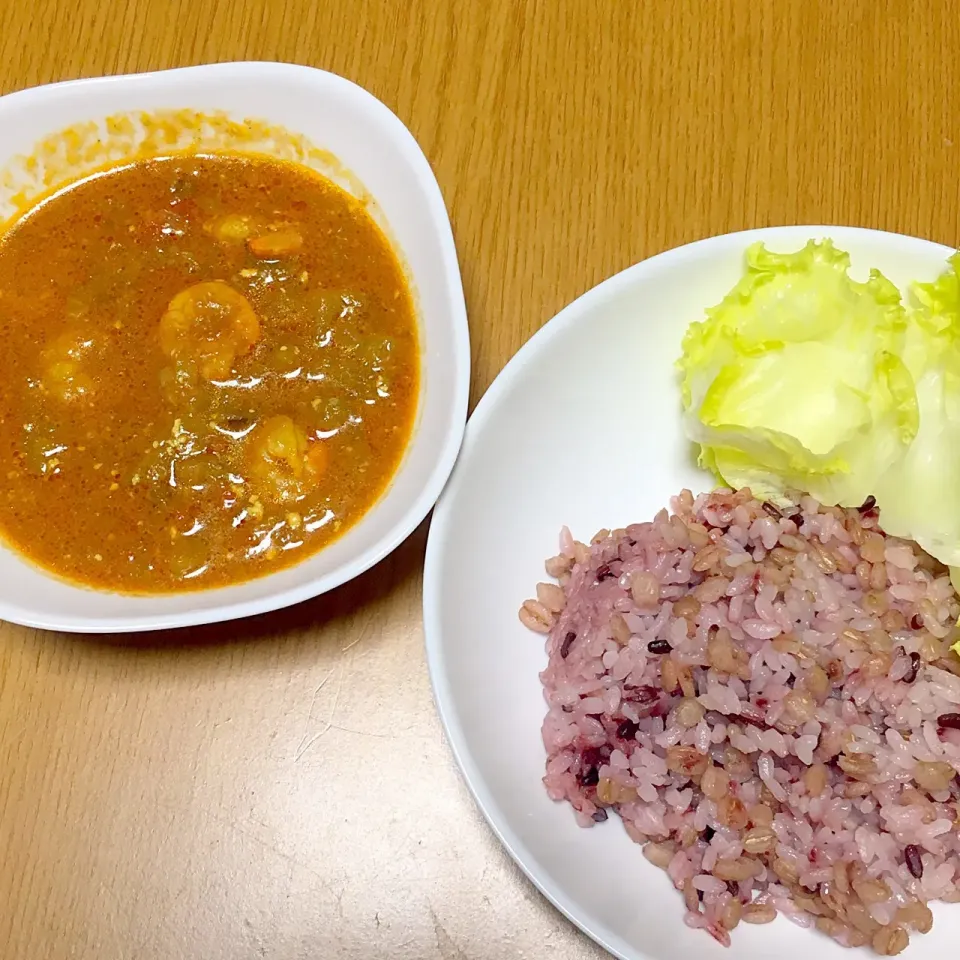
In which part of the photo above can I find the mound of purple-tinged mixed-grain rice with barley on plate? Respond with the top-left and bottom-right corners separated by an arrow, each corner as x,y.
520,490 -> 960,956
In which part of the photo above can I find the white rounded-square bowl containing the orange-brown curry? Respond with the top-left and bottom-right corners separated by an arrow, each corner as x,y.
0,63 -> 470,633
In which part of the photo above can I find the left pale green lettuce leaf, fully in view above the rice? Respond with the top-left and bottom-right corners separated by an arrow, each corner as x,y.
678,240 -> 920,506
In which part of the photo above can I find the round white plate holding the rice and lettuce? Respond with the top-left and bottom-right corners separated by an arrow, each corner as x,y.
424,227 -> 960,960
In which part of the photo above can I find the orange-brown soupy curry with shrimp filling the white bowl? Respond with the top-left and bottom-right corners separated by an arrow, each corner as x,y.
0,154 -> 420,593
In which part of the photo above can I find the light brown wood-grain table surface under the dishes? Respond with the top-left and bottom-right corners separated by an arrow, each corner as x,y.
0,0 -> 960,960
